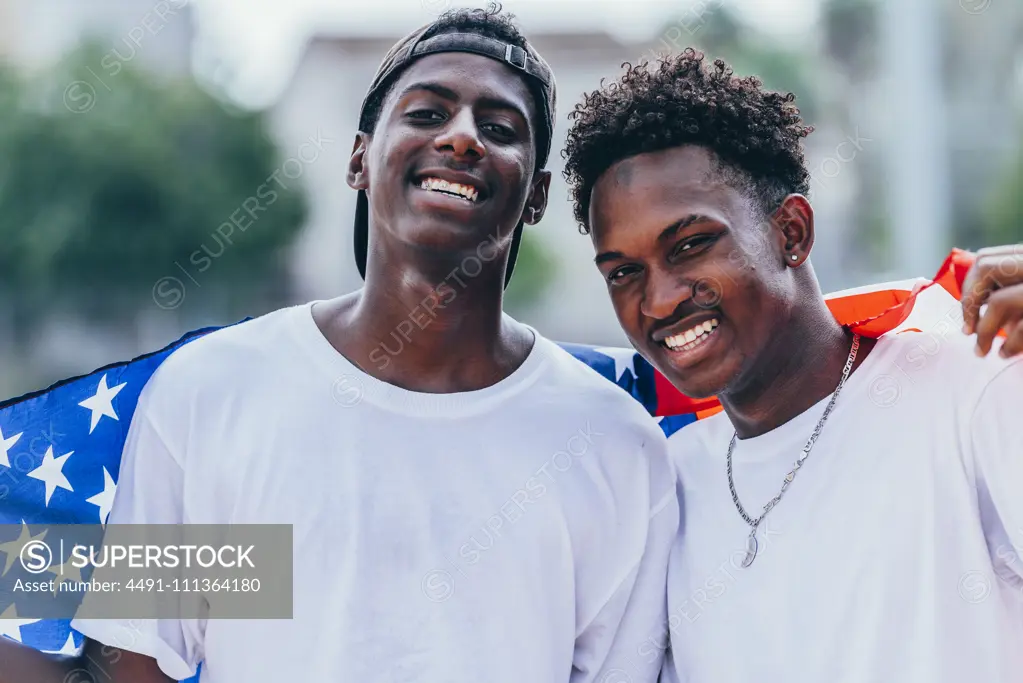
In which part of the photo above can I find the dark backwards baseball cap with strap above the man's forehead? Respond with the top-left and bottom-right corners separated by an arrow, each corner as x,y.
355,21 -> 558,286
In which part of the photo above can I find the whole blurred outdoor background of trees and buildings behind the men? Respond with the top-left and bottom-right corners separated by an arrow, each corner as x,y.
0,0 -> 1023,399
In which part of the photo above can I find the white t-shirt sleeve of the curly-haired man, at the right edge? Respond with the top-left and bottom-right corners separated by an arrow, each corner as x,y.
970,359 -> 1023,581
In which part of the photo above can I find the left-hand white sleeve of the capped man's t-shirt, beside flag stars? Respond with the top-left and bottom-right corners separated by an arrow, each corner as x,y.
72,380 -> 206,680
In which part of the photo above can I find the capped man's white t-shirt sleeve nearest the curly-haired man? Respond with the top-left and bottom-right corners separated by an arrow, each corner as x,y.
570,437 -> 679,683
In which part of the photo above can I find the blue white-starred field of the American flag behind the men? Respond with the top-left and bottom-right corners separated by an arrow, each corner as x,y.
0,328 -> 696,683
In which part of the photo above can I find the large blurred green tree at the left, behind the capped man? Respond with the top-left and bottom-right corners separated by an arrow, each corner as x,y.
0,44 -> 307,335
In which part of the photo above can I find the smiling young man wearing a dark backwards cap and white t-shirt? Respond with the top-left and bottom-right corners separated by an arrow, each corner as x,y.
0,5 -> 678,683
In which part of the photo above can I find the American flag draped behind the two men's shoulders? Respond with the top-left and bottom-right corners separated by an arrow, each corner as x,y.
0,249 -> 974,683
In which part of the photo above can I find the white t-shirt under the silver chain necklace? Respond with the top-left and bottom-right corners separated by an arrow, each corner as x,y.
665,330 -> 1023,683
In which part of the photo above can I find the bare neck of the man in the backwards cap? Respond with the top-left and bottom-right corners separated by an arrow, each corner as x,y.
313,268 -> 533,394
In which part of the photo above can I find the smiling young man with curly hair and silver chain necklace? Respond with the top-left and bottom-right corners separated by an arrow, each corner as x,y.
566,50 -> 1023,683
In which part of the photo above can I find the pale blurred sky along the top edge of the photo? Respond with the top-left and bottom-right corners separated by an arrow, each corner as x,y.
192,0 -> 819,106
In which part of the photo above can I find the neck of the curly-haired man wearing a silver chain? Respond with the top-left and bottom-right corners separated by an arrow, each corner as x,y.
719,301 -> 876,439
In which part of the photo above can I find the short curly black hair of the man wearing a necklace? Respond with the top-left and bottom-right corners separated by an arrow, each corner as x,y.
562,48 -> 813,234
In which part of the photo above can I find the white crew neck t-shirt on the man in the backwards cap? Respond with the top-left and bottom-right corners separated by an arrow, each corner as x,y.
73,304 -> 678,683
